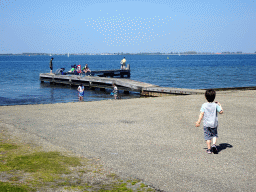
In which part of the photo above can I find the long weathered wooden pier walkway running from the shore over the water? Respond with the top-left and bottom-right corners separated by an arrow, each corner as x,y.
40,73 -> 205,96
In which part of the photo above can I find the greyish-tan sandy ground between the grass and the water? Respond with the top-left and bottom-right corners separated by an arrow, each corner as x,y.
0,90 -> 256,191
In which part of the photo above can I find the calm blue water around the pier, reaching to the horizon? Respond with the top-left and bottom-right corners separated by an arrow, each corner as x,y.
0,55 -> 256,105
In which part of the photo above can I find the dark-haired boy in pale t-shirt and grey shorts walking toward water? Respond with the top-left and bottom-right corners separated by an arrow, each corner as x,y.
196,89 -> 223,154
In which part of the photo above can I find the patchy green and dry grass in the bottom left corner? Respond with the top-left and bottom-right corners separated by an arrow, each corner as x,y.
0,128 -> 154,192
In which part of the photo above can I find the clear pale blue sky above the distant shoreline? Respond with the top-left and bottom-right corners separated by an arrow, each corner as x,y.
0,0 -> 256,54
